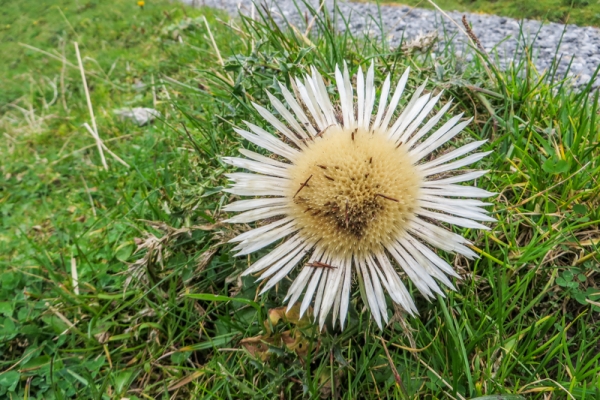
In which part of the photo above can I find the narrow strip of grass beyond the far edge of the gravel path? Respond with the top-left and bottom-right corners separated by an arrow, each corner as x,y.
376,0 -> 600,27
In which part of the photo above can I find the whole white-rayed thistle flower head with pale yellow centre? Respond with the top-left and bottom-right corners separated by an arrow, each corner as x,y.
224,65 -> 494,327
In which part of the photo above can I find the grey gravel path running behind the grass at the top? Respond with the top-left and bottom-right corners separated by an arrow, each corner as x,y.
182,0 -> 600,87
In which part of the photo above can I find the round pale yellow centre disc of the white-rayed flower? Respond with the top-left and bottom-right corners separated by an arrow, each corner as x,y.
288,126 -> 422,256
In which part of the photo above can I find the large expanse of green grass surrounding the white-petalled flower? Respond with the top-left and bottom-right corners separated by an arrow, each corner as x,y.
0,0 -> 600,399
